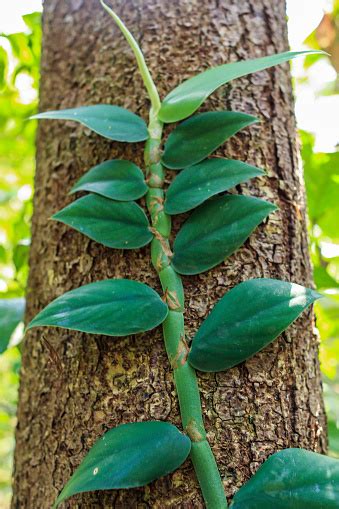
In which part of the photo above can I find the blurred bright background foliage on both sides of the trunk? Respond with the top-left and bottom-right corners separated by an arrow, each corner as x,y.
0,0 -> 339,509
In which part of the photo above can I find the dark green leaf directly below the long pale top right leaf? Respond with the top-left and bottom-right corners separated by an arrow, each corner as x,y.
162,111 -> 258,170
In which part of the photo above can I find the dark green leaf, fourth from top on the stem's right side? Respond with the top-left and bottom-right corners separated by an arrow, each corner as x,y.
172,195 -> 277,275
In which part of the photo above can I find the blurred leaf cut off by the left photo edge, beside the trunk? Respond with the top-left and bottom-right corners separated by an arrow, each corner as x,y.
0,298 -> 25,353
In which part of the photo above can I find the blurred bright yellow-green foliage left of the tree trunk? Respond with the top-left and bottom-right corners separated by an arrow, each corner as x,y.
0,12 -> 41,509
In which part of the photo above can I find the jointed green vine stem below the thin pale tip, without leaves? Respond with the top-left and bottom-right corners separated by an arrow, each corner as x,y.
145,115 -> 227,509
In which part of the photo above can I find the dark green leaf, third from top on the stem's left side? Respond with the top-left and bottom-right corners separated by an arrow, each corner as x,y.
52,194 -> 153,249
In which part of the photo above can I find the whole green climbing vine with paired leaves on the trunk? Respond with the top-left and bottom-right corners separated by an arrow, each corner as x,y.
28,0 -> 339,509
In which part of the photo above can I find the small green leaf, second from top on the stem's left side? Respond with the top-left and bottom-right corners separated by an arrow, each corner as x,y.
70,159 -> 147,201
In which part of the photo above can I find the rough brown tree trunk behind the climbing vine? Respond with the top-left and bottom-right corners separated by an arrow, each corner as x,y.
12,0 -> 326,509
